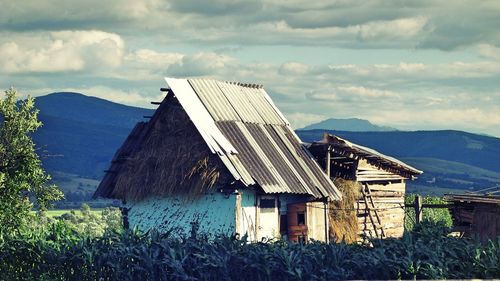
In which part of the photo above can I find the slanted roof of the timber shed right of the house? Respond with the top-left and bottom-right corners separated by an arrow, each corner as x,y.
309,132 -> 422,178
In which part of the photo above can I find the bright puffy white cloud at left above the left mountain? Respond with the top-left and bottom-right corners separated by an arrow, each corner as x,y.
0,30 -> 124,73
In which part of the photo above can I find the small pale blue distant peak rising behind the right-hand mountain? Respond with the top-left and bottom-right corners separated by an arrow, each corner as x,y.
299,118 -> 396,132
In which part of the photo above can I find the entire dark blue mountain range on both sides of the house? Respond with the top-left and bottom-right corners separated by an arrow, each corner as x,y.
34,93 -> 500,197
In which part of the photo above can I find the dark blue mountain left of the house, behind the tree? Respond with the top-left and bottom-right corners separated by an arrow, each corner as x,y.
33,93 -> 153,179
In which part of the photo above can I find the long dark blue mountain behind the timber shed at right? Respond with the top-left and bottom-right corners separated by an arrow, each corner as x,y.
297,130 -> 500,190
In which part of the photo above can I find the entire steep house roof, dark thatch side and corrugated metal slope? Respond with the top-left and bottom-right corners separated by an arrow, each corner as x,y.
94,78 -> 340,200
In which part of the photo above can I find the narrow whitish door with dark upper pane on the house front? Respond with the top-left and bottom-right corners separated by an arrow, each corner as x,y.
257,196 -> 279,240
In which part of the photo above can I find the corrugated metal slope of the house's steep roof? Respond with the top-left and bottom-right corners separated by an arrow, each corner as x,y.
167,79 -> 340,199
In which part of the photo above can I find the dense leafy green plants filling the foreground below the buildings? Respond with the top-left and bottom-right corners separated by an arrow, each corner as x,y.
0,221 -> 500,280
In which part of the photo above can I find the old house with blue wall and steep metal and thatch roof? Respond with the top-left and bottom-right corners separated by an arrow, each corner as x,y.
94,78 -> 341,241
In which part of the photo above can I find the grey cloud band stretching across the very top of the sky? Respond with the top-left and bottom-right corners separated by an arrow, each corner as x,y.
0,0 -> 500,50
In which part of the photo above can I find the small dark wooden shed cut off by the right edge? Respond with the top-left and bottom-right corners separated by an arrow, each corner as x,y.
445,191 -> 500,242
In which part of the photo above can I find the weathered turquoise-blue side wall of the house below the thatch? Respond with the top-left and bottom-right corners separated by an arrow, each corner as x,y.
127,193 -> 236,236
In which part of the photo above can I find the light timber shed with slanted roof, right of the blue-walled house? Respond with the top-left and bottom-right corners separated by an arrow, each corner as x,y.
309,133 -> 422,238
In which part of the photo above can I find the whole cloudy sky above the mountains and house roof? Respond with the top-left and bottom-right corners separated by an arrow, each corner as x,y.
0,0 -> 500,137
